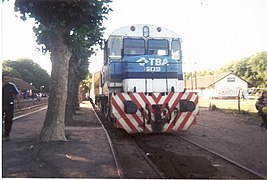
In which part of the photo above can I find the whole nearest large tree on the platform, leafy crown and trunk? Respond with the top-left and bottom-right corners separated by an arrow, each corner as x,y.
15,0 -> 110,141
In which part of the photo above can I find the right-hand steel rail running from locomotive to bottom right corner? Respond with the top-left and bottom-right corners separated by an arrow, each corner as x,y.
171,133 -> 267,179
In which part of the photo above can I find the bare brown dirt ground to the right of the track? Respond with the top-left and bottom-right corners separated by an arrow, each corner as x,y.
187,108 -> 267,177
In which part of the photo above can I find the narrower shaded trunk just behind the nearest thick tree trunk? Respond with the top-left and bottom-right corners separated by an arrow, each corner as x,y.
65,56 -> 78,122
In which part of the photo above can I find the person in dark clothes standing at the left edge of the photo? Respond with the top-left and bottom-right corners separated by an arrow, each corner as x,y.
2,75 -> 20,140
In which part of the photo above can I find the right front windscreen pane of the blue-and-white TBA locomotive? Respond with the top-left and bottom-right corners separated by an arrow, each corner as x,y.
148,39 -> 169,56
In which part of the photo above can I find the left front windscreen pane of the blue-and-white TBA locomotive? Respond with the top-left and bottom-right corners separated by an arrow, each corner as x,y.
123,38 -> 145,55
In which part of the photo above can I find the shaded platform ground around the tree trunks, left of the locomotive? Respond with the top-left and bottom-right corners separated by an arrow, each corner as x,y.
2,101 -> 121,178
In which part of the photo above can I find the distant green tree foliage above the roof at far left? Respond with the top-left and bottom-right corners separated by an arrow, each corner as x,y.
2,59 -> 50,92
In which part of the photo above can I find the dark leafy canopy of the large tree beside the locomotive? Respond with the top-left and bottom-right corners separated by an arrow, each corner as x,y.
15,0 -> 111,55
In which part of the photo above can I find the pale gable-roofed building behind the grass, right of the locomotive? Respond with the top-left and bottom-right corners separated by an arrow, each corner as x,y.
185,73 -> 249,98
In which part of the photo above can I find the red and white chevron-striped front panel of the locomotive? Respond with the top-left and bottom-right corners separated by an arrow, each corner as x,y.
110,92 -> 199,133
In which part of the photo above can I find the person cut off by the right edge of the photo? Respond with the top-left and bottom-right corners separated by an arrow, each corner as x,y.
255,91 -> 267,131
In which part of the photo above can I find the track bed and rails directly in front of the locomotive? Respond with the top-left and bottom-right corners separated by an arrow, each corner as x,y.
130,133 -> 266,179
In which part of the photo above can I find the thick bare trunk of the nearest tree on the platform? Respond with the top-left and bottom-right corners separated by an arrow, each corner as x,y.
40,33 -> 71,142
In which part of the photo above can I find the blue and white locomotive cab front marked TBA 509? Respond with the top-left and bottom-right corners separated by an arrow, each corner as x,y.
102,25 -> 183,93
